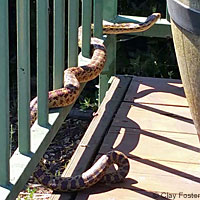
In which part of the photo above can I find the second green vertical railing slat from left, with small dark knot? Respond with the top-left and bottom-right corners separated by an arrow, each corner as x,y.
17,0 -> 30,154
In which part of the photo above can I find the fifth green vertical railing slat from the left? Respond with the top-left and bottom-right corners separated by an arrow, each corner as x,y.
68,0 -> 79,67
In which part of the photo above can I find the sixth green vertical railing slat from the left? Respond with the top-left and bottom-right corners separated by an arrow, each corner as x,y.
82,0 -> 92,58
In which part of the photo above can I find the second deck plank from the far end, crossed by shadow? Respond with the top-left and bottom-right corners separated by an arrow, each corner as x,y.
112,102 -> 196,133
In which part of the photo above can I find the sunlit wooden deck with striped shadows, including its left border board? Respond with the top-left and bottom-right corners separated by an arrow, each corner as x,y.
52,76 -> 200,200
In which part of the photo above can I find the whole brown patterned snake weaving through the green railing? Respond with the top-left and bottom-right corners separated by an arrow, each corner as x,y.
30,13 -> 161,192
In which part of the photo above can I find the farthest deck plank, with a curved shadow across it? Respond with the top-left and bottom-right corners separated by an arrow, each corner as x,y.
124,77 -> 188,106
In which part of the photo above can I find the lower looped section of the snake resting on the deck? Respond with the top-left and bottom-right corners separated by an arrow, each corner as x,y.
34,151 -> 129,192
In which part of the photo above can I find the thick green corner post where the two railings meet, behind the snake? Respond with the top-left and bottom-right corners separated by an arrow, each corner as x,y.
99,0 -> 117,104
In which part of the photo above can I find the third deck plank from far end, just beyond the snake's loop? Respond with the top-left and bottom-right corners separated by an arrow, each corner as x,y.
99,127 -> 200,165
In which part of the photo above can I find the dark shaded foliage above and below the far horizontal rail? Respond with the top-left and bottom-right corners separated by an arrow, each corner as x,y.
117,0 -> 180,78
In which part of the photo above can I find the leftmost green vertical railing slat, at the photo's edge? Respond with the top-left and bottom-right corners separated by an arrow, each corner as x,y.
0,0 -> 10,186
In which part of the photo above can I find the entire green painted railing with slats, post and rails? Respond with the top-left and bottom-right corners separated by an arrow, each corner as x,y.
0,0 -> 171,200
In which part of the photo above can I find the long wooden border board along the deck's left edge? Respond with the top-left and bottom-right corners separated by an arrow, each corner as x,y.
51,76 -> 131,200
